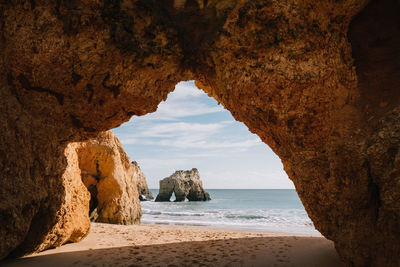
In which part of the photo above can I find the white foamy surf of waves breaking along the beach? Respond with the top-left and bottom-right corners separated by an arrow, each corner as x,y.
142,192 -> 320,235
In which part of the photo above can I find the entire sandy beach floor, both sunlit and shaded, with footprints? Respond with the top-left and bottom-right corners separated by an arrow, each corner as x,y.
0,223 -> 342,267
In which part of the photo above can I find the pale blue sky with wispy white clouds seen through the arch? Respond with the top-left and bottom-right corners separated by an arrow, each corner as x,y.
113,81 -> 294,189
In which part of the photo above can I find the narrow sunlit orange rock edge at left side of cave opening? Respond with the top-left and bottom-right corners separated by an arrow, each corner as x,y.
5,143 -> 90,256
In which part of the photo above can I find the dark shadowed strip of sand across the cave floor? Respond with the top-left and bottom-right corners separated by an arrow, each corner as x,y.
0,236 -> 342,267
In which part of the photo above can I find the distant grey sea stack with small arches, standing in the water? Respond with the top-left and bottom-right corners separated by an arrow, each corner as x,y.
155,168 -> 211,202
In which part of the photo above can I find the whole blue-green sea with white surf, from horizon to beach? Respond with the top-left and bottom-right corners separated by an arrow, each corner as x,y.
141,189 -> 321,236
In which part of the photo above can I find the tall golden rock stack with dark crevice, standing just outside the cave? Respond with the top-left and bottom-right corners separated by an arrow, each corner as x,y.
77,131 -> 142,224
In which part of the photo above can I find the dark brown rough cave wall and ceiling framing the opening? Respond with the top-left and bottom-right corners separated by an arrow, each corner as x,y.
0,0 -> 400,266
